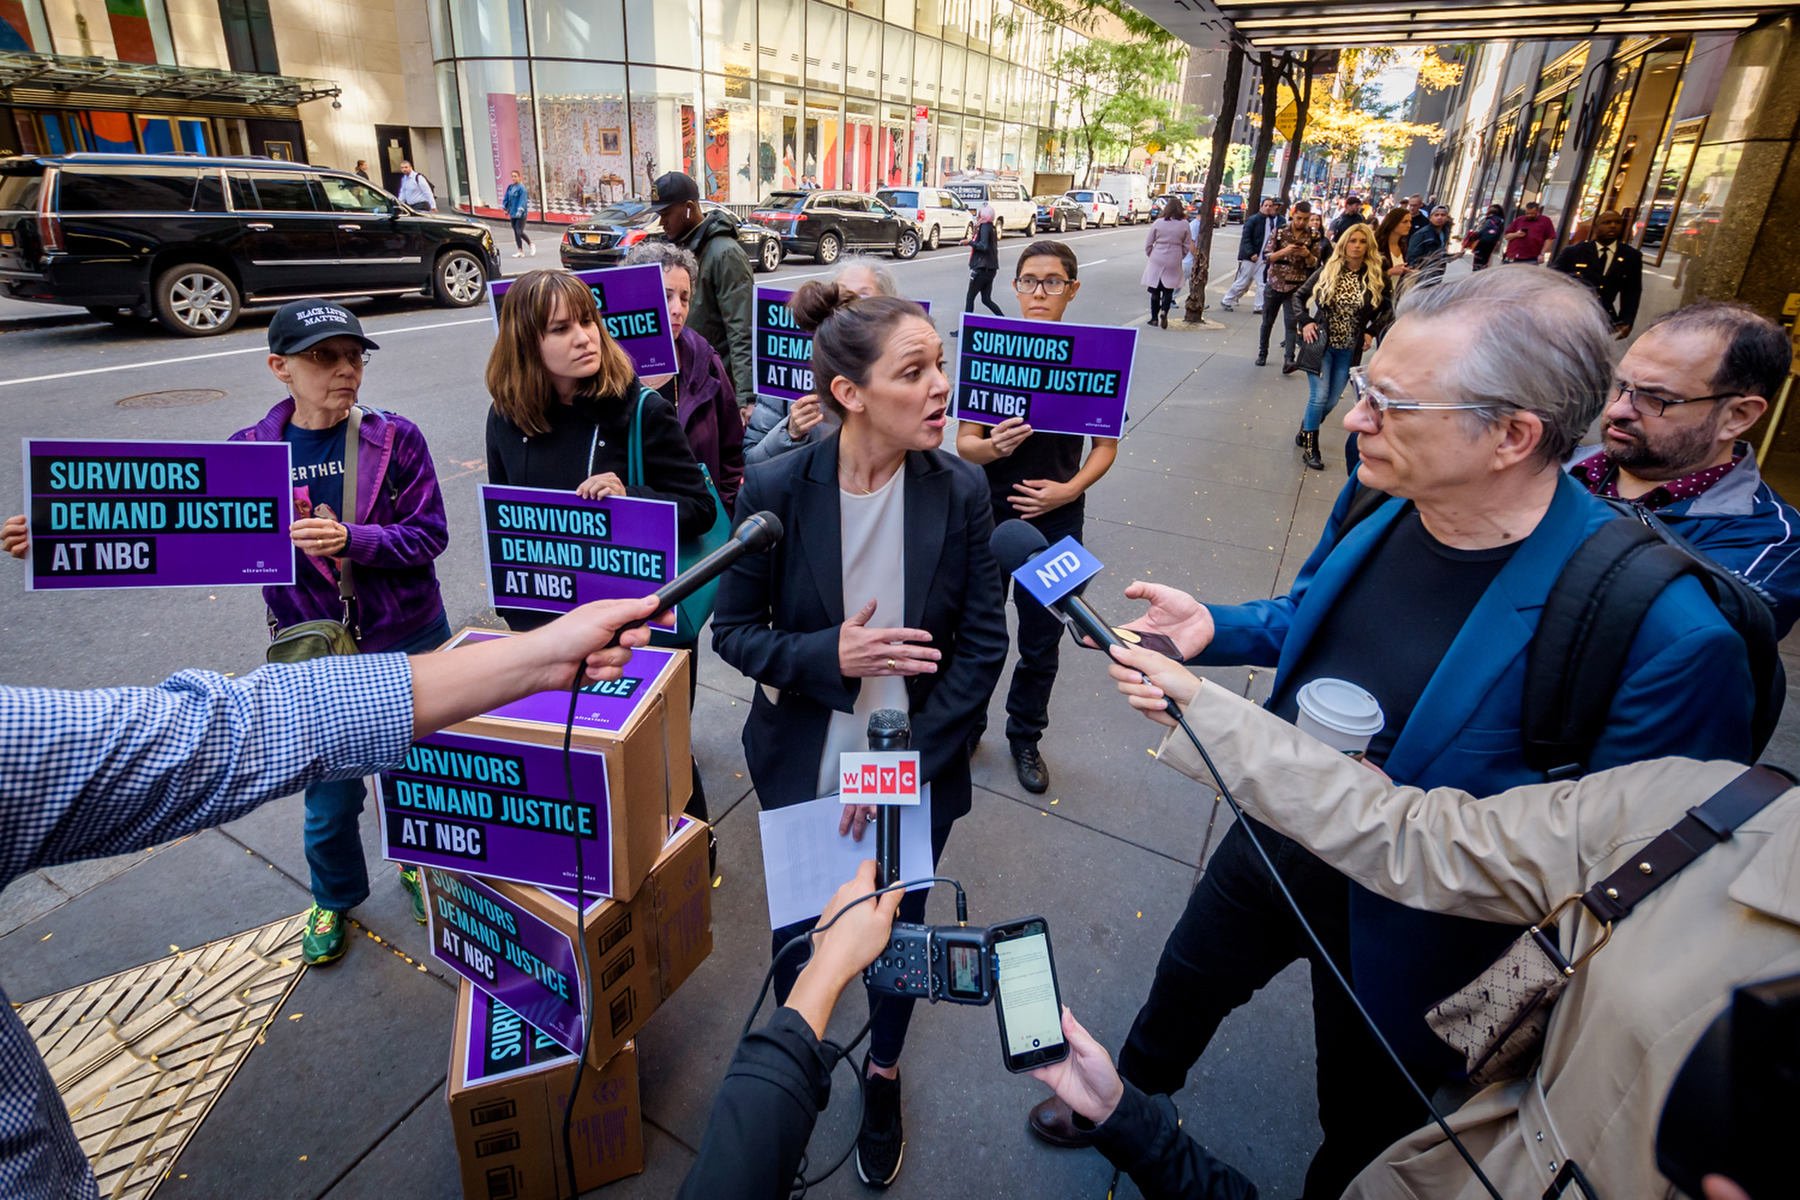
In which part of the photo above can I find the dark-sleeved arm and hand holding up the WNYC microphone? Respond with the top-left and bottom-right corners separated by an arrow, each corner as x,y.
680,860 -> 902,1200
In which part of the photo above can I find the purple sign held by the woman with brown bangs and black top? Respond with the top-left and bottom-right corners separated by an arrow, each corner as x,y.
481,484 -> 680,633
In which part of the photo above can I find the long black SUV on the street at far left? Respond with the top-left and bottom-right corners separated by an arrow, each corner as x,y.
0,155 -> 500,336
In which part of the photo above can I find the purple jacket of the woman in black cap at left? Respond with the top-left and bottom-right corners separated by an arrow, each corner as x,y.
230,396 -> 450,651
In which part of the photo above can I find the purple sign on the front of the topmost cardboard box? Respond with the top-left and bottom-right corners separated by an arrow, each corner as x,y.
380,734 -> 612,896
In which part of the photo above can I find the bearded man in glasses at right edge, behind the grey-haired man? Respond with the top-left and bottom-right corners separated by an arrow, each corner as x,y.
1570,300 -> 1800,637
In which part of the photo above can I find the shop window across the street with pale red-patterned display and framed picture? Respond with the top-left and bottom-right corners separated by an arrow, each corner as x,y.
525,63 -> 626,214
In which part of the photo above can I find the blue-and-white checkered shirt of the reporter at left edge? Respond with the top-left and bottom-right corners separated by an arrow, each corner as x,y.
0,655 -> 412,1200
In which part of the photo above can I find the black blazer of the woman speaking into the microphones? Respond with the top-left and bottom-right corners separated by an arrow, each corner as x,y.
713,434 -> 1006,826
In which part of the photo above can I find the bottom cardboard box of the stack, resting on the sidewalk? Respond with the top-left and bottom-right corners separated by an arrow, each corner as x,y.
446,981 -> 644,1200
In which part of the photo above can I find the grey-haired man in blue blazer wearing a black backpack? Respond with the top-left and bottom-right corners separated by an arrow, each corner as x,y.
1031,268 -> 1751,1198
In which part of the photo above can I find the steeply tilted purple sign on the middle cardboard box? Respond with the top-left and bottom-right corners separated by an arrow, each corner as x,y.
425,869 -> 581,1051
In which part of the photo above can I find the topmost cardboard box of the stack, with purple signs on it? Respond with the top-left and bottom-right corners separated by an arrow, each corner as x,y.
380,630 -> 693,900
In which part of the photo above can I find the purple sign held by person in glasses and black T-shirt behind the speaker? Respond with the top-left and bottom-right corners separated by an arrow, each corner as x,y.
956,313 -> 1138,437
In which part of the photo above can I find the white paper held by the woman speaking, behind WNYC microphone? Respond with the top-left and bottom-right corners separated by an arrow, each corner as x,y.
760,783 -> 936,928
